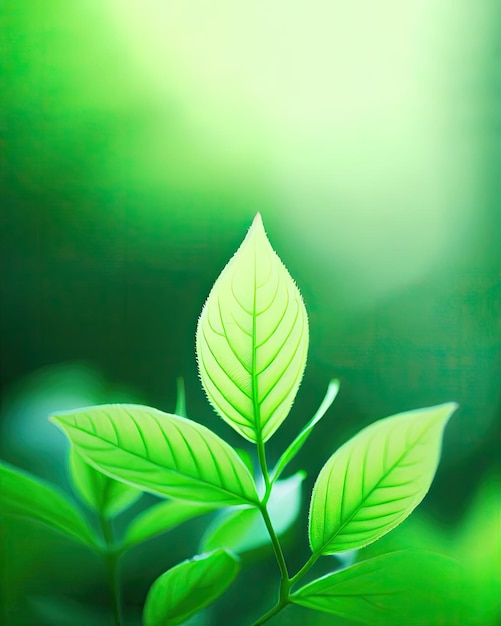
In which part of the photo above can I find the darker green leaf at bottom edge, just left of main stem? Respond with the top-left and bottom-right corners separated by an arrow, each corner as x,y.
144,550 -> 239,626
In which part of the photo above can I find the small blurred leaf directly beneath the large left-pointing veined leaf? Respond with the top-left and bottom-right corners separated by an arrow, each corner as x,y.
124,500 -> 214,548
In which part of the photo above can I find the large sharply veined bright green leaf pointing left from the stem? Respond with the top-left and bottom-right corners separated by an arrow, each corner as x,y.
51,404 -> 258,505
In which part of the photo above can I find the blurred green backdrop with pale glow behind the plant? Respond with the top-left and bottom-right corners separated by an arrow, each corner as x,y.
0,0 -> 501,626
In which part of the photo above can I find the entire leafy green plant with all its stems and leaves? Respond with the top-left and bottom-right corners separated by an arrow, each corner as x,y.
0,214 -> 456,626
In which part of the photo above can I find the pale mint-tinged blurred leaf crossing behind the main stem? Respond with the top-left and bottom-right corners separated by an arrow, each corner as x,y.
202,472 -> 305,554
